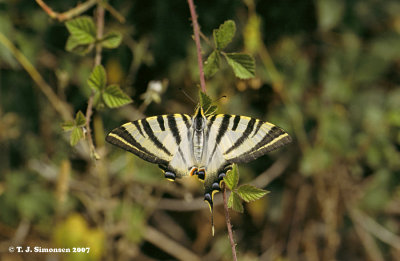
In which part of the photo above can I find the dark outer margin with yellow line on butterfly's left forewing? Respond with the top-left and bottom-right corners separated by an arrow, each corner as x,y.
106,126 -> 168,166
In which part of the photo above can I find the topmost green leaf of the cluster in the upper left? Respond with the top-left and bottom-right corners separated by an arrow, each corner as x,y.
65,16 -> 96,45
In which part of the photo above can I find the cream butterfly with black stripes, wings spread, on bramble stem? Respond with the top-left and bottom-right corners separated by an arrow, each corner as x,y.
106,106 -> 291,233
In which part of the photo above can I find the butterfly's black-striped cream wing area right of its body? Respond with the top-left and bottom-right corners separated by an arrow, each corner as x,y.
205,114 -> 291,194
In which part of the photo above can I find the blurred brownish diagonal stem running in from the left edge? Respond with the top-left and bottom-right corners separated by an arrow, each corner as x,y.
0,32 -> 72,121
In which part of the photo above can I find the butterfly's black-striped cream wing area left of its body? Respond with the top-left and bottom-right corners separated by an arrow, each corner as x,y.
106,114 -> 192,176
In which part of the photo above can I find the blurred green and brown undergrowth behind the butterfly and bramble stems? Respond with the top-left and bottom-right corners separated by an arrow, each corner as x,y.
0,0 -> 400,260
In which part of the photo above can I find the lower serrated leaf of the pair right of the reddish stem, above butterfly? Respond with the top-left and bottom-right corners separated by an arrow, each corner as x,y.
224,53 -> 256,79
